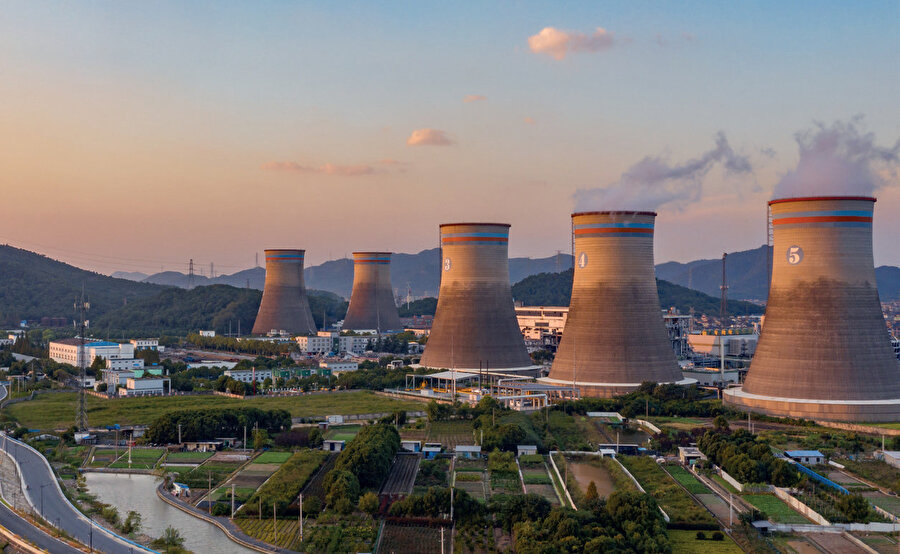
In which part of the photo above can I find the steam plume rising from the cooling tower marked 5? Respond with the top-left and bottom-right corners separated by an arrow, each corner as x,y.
774,117 -> 900,198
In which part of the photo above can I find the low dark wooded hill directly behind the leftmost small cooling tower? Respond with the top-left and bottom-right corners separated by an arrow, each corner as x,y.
91,285 -> 347,338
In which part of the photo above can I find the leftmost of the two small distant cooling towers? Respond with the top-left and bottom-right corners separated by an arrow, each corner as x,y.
253,249 -> 316,335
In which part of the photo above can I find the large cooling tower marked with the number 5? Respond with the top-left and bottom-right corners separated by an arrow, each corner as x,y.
724,197 -> 900,421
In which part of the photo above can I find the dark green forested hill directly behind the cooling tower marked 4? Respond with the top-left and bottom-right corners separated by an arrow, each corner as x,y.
512,269 -> 765,315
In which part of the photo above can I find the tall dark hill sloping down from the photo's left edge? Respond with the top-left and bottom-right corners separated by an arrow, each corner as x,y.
0,245 -> 165,327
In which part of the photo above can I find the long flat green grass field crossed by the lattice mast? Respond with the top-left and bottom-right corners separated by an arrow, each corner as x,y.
6,391 -> 424,430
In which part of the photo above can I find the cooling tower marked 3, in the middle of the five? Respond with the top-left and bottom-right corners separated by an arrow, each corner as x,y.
420,223 -> 534,371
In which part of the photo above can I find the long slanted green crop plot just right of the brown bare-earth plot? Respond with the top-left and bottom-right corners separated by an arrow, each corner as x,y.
619,456 -> 719,529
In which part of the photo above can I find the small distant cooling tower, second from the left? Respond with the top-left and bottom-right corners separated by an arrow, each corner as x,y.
343,252 -> 403,333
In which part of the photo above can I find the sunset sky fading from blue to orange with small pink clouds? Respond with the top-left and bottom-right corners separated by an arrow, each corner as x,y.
0,0 -> 900,273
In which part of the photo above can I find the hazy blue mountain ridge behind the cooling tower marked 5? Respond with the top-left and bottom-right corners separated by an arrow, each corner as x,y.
656,245 -> 900,301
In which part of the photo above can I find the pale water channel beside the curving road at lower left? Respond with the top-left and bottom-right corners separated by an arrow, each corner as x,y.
84,473 -> 254,554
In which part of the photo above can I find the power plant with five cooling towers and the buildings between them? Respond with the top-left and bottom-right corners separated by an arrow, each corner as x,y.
239,193 -> 900,421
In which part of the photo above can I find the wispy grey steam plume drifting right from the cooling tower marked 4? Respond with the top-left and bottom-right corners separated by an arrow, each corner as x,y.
575,132 -> 753,211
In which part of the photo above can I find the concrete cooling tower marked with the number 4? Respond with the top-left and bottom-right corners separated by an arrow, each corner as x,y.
544,211 -> 694,397
